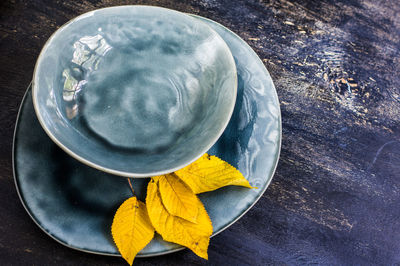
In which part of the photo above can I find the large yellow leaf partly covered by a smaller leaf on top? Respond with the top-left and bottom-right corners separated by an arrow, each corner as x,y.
146,179 -> 213,259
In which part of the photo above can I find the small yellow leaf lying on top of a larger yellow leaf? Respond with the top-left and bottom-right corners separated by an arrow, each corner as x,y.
153,173 -> 199,223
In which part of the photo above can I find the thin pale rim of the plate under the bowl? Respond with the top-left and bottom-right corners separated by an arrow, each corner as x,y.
12,13 -> 282,258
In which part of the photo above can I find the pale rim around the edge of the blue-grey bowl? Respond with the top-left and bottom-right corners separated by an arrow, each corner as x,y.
32,5 -> 238,178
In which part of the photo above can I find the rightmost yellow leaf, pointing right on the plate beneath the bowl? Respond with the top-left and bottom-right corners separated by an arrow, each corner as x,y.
175,153 -> 253,194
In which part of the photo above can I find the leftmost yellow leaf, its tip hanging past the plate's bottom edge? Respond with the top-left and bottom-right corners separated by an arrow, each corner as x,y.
111,197 -> 154,265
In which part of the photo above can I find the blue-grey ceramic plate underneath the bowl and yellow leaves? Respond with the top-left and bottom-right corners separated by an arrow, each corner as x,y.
13,16 -> 281,257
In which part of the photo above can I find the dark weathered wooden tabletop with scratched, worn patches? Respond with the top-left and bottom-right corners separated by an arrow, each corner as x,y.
0,0 -> 400,265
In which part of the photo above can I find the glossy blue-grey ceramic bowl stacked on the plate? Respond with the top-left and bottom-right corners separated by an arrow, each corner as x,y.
32,6 -> 237,177
